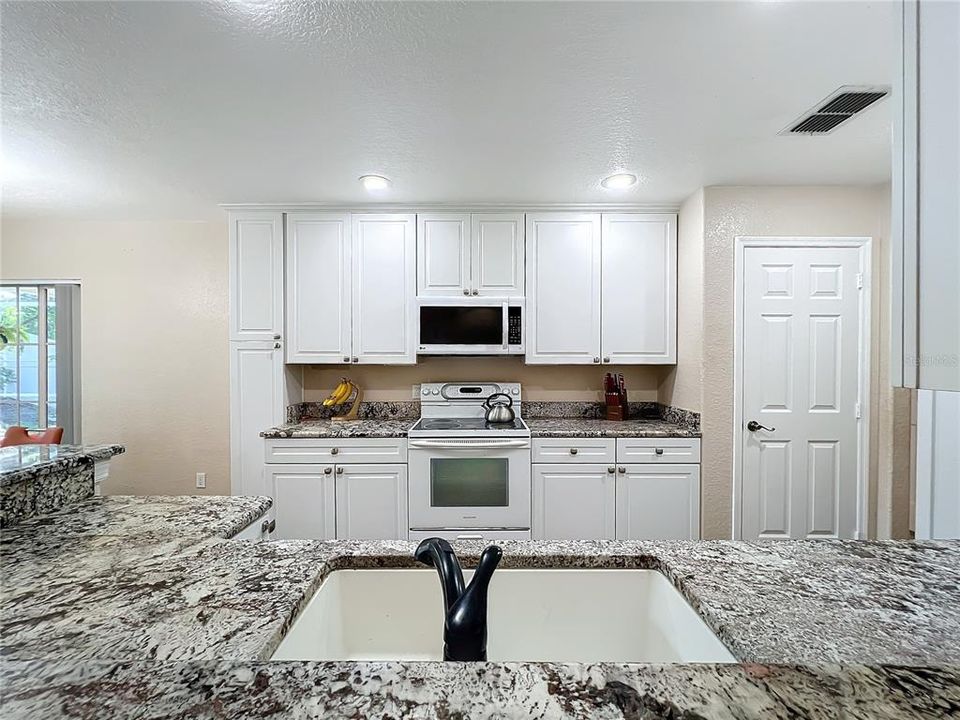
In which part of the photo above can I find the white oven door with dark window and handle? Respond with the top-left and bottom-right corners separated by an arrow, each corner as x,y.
407,438 -> 530,530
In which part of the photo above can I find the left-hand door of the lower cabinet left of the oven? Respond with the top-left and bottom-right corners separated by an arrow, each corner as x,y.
266,465 -> 337,540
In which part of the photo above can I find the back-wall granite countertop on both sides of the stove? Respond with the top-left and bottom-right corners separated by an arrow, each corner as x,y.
260,417 -> 700,438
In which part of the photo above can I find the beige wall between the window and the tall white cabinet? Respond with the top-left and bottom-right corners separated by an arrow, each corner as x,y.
0,218 -> 230,494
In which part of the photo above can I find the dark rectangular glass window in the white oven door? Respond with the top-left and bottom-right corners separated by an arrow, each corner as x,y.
430,458 -> 510,507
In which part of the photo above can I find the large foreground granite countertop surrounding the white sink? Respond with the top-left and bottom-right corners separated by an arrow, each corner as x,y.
0,498 -> 960,718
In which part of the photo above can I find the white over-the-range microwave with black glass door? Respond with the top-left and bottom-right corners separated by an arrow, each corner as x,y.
417,297 -> 525,355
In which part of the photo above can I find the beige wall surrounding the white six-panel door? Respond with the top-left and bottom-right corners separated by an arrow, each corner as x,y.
677,186 -> 896,538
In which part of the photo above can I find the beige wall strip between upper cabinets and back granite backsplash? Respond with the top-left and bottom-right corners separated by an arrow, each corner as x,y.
303,358 -> 667,401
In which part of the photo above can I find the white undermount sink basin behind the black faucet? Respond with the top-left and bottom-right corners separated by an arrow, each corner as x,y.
273,568 -> 736,663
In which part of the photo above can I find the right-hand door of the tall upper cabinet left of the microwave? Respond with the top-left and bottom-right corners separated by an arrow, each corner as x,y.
351,215 -> 417,365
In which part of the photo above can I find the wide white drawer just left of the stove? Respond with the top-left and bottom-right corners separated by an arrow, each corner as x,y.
266,438 -> 407,464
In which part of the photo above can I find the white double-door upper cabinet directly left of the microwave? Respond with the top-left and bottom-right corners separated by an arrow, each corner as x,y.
286,213 -> 416,365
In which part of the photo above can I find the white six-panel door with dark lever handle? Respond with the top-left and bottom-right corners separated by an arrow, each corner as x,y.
738,246 -> 863,540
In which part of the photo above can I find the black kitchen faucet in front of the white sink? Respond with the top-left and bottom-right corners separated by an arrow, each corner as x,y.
414,538 -> 503,660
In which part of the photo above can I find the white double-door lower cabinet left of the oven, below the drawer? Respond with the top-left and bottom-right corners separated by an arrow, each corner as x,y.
266,464 -> 407,540
